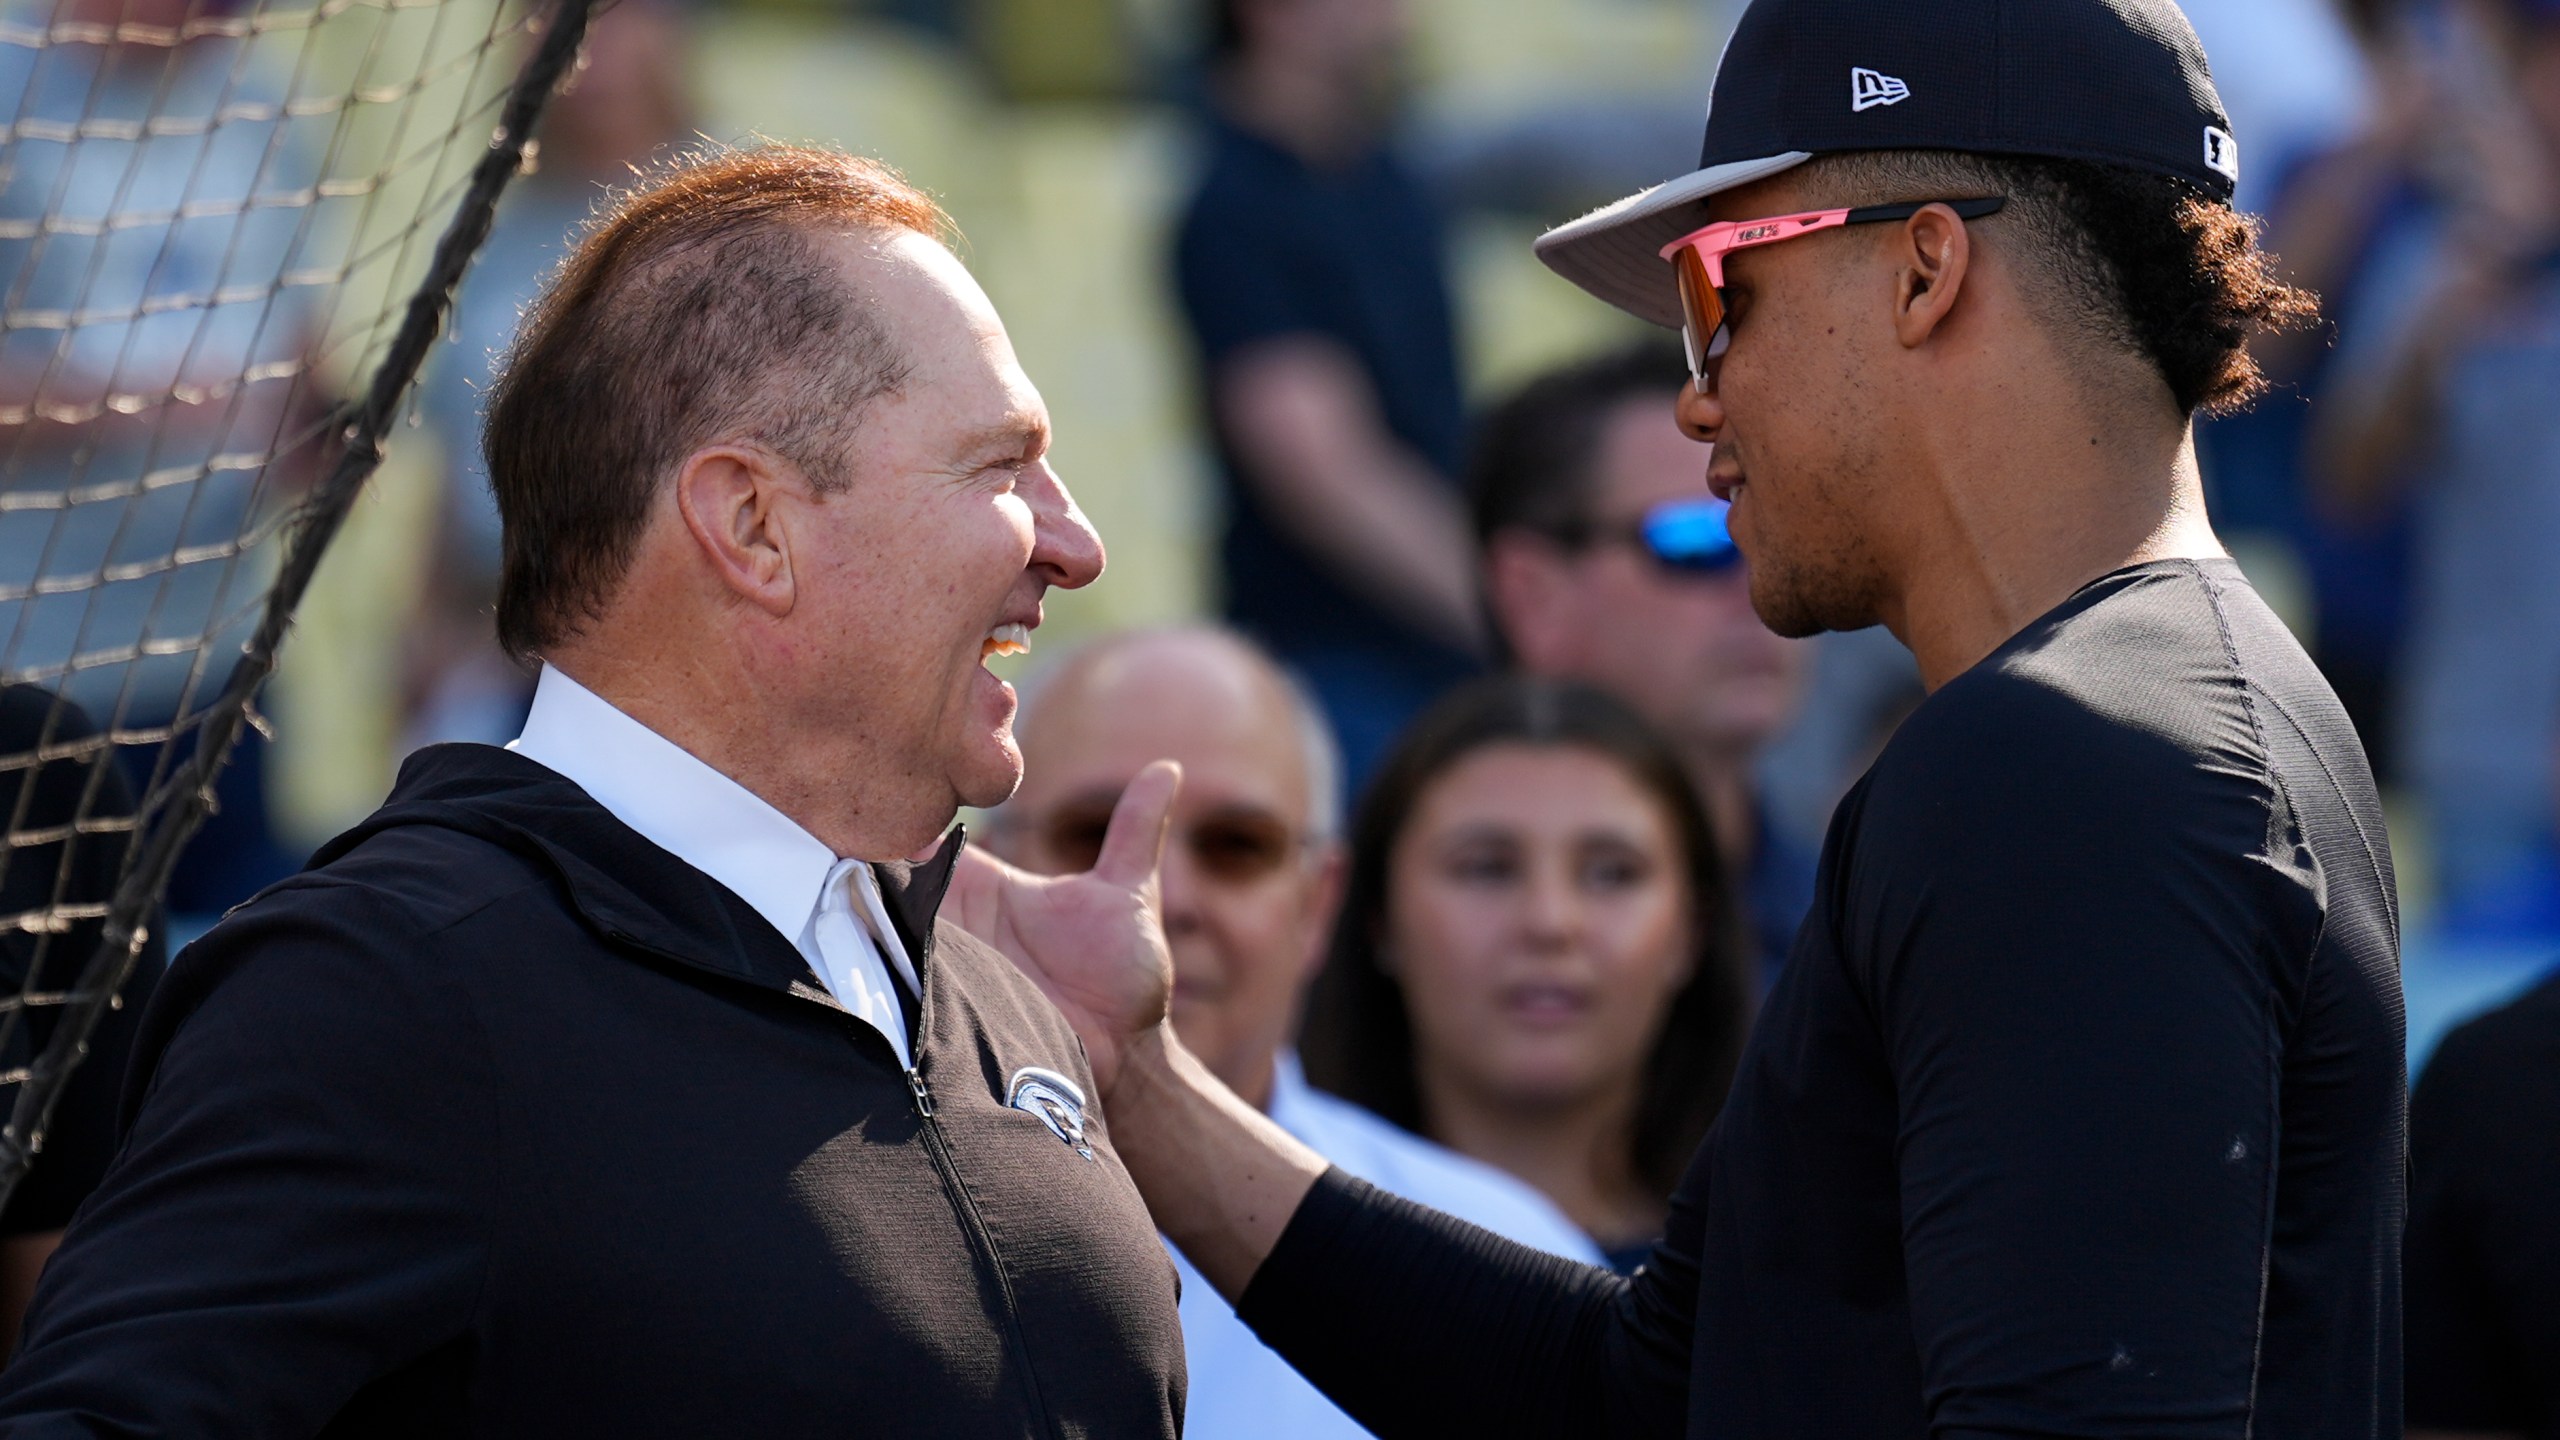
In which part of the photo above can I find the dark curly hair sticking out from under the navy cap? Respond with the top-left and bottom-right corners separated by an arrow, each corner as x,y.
1805,151 -> 2319,415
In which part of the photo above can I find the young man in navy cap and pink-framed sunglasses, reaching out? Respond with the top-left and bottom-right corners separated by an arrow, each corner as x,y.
963,0 -> 2404,1440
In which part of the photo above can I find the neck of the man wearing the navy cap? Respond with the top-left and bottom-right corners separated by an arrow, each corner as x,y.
1882,386 -> 2225,689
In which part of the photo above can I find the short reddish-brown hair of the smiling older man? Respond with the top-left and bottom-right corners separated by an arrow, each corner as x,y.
481,146 -> 952,659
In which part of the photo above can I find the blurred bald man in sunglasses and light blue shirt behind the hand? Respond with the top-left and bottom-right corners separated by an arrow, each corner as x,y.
991,628 -> 1597,1440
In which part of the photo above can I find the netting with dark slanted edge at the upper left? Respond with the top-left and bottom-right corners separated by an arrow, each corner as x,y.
0,0 -> 589,1204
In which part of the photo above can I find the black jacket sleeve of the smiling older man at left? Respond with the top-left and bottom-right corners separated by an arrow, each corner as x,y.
0,881 -> 497,1437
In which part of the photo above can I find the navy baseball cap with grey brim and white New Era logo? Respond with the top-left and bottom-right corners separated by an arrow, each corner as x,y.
1536,0 -> 2240,325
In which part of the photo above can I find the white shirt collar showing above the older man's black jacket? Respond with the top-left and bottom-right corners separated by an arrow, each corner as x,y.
507,666 -> 916,1068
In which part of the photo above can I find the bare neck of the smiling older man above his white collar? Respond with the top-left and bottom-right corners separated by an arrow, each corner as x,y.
543,641 -> 947,861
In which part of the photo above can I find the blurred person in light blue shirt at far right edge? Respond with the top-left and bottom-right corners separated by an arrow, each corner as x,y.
2309,0 -> 2560,933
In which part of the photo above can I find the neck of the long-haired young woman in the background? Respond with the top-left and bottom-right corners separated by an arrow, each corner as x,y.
1416,1068 -> 1664,1245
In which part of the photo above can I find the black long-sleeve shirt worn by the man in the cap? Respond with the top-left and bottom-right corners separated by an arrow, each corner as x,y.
1242,561 -> 2406,1440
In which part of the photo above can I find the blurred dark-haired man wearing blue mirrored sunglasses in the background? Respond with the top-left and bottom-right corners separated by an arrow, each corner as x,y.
1469,346 -> 1812,974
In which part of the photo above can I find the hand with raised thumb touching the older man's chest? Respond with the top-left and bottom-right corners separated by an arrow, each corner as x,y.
942,761 -> 1183,1081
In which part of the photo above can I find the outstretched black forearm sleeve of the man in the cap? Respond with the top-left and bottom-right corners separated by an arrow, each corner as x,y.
1236,1163 -> 1705,1440
